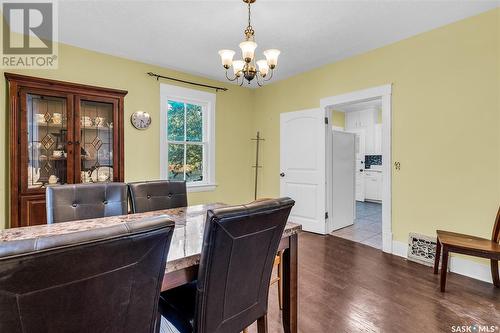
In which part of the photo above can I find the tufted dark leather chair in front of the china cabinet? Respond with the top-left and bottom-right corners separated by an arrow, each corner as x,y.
45,183 -> 128,224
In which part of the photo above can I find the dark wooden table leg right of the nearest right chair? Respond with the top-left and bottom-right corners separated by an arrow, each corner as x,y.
283,234 -> 298,333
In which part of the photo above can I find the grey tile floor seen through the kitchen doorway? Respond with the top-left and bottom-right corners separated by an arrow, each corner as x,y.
331,201 -> 382,249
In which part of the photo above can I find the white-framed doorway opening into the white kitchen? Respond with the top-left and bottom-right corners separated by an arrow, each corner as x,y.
320,85 -> 392,253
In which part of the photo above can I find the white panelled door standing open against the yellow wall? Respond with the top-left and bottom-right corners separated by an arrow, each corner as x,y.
280,109 -> 329,234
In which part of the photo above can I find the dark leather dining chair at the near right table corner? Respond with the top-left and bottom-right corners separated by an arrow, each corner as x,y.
160,198 -> 295,333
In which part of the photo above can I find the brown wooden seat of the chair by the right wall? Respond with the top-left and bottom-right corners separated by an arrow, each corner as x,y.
437,230 -> 500,253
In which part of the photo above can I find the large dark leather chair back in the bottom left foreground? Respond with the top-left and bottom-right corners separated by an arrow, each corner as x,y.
0,216 -> 174,333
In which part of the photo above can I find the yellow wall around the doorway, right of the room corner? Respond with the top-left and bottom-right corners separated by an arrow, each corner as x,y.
255,9 -> 500,242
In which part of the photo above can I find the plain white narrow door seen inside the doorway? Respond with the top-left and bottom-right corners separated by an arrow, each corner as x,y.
329,131 -> 356,230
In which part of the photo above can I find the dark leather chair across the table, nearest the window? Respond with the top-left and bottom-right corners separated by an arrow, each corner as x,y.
128,180 -> 188,213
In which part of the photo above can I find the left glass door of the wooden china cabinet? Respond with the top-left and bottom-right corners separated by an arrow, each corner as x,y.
20,91 -> 73,192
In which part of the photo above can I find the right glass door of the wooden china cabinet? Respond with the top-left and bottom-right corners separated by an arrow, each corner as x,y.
75,96 -> 118,183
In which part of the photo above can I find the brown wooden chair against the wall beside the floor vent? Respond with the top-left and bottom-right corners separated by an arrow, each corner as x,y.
434,207 -> 500,292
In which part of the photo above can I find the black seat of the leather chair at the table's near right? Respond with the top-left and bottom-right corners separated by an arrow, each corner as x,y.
159,281 -> 196,333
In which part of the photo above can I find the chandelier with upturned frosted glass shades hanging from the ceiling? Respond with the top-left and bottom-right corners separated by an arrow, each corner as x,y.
219,0 -> 280,86
